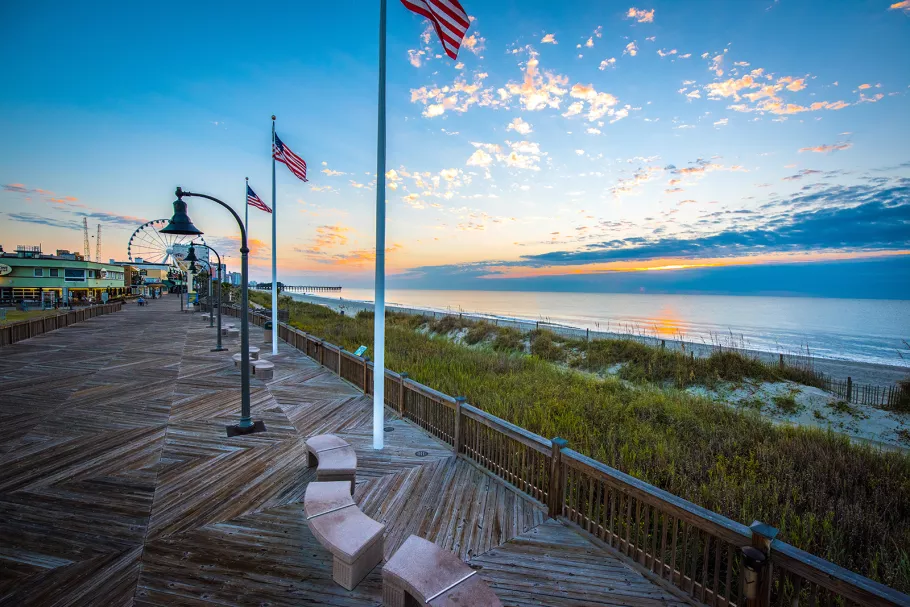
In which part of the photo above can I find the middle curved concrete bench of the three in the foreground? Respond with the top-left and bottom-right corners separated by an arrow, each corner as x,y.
303,481 -> 385,590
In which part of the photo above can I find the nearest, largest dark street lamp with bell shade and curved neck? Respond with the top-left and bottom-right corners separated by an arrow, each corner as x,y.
161,187 -> 265,436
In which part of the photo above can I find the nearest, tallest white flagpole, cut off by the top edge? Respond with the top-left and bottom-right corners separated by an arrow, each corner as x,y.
373,0 -> 386,449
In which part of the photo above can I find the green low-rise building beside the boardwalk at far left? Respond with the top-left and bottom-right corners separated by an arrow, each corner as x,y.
0,245 -> 129,306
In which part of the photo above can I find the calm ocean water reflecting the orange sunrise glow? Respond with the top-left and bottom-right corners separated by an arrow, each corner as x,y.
292,288 -> 910,368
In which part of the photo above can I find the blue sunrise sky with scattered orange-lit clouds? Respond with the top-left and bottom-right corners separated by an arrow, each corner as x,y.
0,0 -> 910,299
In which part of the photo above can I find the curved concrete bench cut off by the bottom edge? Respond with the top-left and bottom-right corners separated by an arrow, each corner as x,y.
382,535 -> 502,607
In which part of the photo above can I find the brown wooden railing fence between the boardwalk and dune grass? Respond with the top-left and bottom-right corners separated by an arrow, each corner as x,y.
224,306 -> 910,607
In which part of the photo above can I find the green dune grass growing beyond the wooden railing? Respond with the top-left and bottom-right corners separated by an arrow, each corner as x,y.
253,294 -> 910,592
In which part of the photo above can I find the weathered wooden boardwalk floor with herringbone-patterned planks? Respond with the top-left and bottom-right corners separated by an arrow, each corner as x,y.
0,298 -> 680,607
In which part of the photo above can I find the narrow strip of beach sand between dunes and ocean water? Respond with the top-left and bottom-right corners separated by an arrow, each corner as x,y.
283,293 -> 910,386
